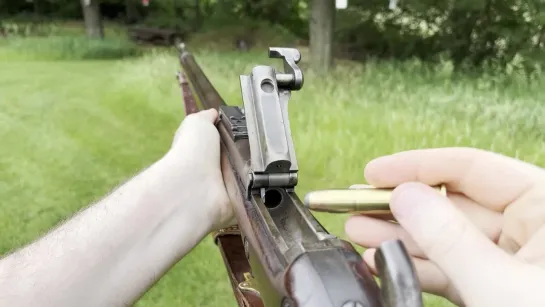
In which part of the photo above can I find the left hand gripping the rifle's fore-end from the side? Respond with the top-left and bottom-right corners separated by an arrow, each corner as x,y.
168,109 -> 234,229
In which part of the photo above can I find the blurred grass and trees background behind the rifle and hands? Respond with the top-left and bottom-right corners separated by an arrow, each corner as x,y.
0,0 -> 545,306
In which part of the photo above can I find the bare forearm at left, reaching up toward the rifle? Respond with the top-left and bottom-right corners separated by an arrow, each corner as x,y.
0,149 -> 215,306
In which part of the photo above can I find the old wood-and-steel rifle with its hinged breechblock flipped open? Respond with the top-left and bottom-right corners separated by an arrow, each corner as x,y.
177,44 -> 422,307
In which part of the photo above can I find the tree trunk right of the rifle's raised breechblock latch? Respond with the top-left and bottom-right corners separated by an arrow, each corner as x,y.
309,0 -> 335,72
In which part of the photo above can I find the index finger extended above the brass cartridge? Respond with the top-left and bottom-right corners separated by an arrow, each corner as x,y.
365,147 -> 545,211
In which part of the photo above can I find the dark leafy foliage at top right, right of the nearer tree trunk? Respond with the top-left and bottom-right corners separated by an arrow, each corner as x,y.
337,0 -> 545,76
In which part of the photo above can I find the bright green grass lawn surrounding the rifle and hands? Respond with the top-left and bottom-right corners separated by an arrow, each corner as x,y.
0,36 -> 545,307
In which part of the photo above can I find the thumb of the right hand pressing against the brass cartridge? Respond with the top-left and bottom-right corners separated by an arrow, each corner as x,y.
391,183 -> 515,305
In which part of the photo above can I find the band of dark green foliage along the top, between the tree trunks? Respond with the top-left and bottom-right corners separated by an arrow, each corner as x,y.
0,0 -> 545,74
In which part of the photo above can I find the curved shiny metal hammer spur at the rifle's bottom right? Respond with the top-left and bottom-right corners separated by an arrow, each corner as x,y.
375,240 -> 423,307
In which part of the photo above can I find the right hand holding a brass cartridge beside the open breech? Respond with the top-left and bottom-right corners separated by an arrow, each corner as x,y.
345,148 -> 545,306
